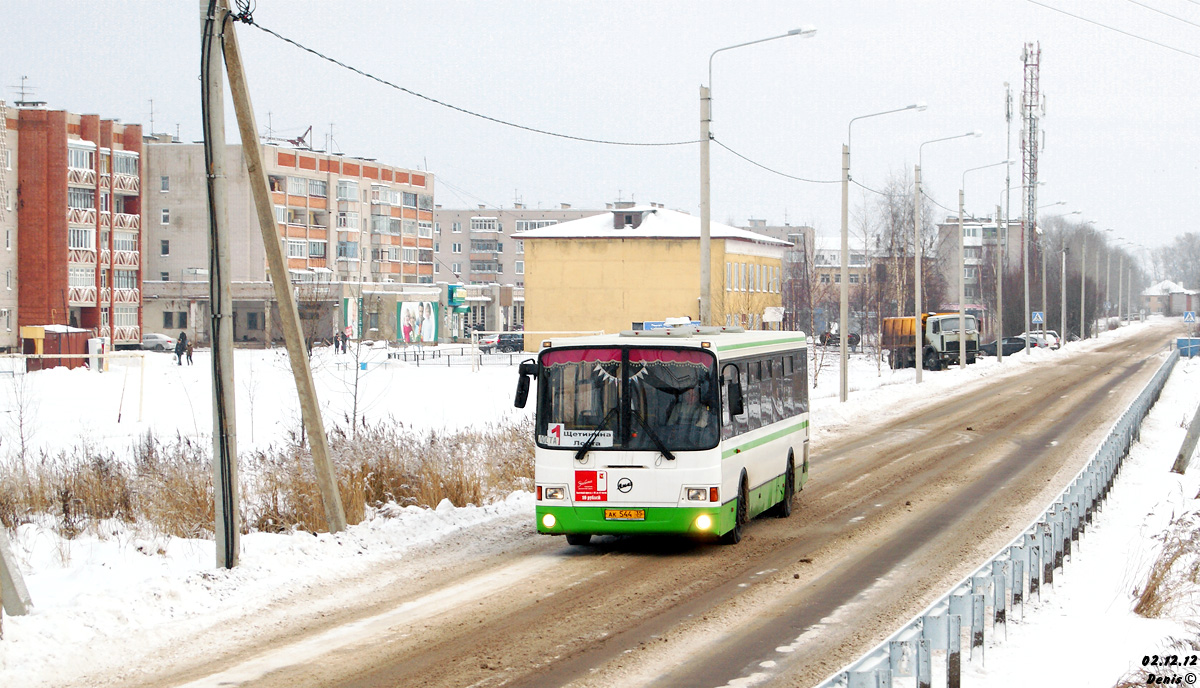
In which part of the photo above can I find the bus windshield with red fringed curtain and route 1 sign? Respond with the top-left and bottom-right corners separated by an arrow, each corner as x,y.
536,347 -> 720,451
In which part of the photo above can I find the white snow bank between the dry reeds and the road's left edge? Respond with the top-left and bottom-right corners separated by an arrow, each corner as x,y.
0,491 -> 534,688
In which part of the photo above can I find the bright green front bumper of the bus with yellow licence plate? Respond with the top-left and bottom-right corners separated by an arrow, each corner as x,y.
535,501 -> 737,538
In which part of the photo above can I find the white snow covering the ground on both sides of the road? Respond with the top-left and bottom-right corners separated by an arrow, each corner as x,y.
0,325 -> 1200,688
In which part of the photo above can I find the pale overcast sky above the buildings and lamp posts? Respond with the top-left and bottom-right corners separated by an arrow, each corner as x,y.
0,0 -> 1200,247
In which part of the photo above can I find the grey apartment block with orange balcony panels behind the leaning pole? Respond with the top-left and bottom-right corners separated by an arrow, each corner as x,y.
146,136 -> 436,341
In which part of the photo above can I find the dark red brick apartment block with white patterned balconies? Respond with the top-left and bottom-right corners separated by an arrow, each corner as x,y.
15,104 -> 144,346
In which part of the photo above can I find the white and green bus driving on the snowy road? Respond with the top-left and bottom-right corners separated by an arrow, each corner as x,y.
516,327 -> 809,545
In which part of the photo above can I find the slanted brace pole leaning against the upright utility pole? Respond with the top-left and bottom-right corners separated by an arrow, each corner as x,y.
217,0 -> 346,533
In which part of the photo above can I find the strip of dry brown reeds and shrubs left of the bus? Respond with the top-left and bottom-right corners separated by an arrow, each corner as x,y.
0,420 -> 533,538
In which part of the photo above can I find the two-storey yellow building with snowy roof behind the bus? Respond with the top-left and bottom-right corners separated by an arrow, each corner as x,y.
512,207 -> 790,333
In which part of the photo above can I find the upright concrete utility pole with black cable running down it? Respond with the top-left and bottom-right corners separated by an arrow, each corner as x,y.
200,0 -> 238,568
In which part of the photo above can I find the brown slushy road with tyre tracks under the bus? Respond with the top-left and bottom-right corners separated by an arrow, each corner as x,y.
108,327 -> 1168,687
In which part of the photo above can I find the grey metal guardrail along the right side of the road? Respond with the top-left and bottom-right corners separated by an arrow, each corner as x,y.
817,349 -> 1180,688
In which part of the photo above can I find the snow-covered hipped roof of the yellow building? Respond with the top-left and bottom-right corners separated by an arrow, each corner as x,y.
512,205 -> 791,247
